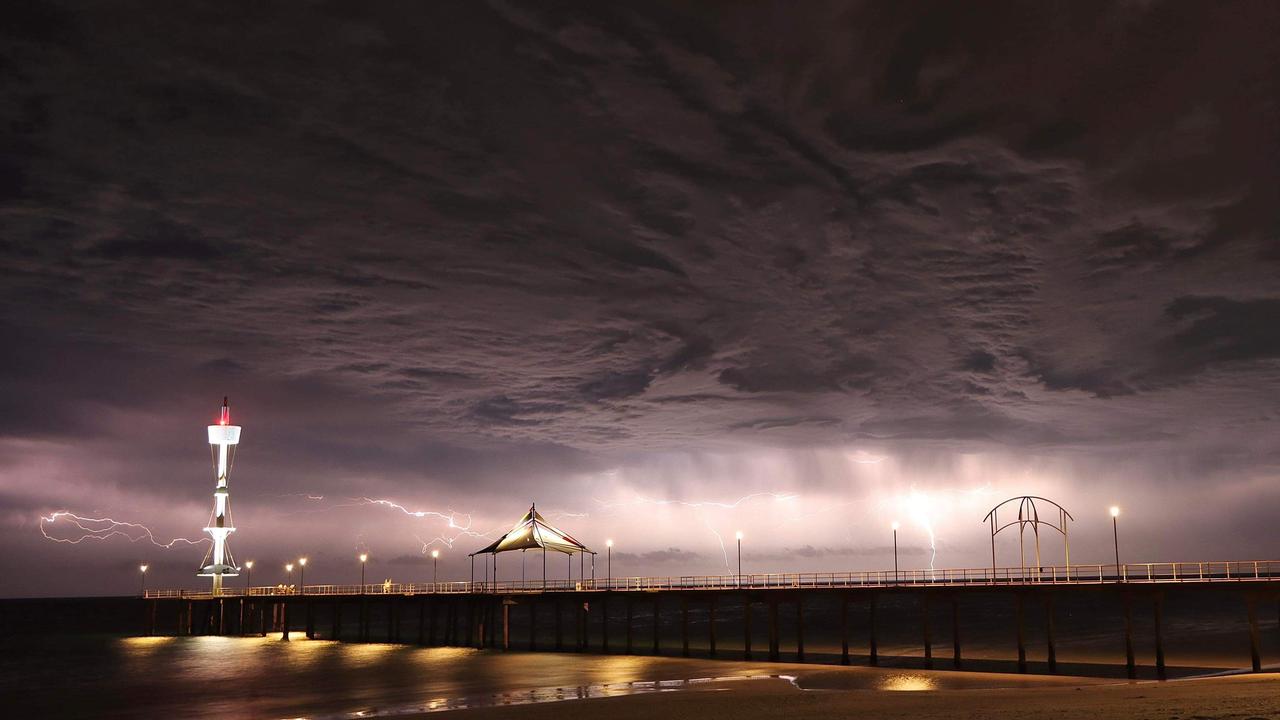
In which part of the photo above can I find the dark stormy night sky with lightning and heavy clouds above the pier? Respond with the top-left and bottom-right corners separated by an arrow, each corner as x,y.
0,1 -> 1280,596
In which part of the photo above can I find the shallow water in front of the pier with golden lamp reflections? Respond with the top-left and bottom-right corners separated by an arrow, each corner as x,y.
0,634 -> 977,719
